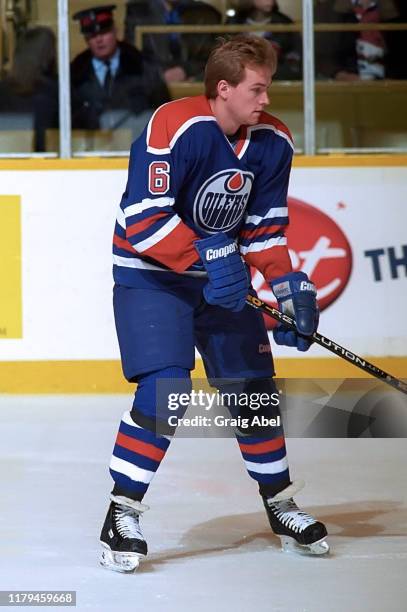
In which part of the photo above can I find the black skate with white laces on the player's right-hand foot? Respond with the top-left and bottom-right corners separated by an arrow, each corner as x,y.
263,482 -> 329,555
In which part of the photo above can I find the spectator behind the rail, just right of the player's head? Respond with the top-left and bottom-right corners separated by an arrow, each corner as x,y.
227,0 -> 302,80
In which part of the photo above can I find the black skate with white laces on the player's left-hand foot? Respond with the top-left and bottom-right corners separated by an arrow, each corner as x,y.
100,495 -> 148,572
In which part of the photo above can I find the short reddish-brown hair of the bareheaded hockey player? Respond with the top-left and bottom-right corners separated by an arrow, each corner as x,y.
204,34 -> 277,98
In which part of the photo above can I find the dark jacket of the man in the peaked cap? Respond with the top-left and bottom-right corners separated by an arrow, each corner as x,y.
71,42 -> 170,130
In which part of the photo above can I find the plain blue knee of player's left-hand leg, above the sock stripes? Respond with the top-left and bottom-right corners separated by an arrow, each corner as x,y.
130,366 -> 192,435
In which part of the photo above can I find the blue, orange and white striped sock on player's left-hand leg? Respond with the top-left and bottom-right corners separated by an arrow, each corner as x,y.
109,411 -> 170,501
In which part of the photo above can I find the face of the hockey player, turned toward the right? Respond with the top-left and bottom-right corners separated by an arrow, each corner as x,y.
225,66 -> 272,125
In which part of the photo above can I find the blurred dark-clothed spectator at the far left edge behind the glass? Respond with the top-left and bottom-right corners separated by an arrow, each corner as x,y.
0,26 -> 58,152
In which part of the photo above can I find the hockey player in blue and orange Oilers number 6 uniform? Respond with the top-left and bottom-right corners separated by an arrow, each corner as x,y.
101,36 -> 329,571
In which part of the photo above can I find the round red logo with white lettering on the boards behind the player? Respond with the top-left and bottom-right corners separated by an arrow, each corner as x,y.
252,197 -> 352,329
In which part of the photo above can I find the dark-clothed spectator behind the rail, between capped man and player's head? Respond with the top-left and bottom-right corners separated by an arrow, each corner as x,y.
125,0 -> 222,83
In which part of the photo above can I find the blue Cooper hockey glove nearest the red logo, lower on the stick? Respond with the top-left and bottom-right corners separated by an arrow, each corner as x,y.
271,272 -> 319,351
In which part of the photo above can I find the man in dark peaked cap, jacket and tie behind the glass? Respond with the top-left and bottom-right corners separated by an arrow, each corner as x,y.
71,5 -> 170,138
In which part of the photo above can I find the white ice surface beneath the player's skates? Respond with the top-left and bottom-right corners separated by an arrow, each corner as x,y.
0,395 -> 407,612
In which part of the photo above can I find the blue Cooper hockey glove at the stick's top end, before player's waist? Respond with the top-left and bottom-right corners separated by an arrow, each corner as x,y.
194,232 -> 249,312
